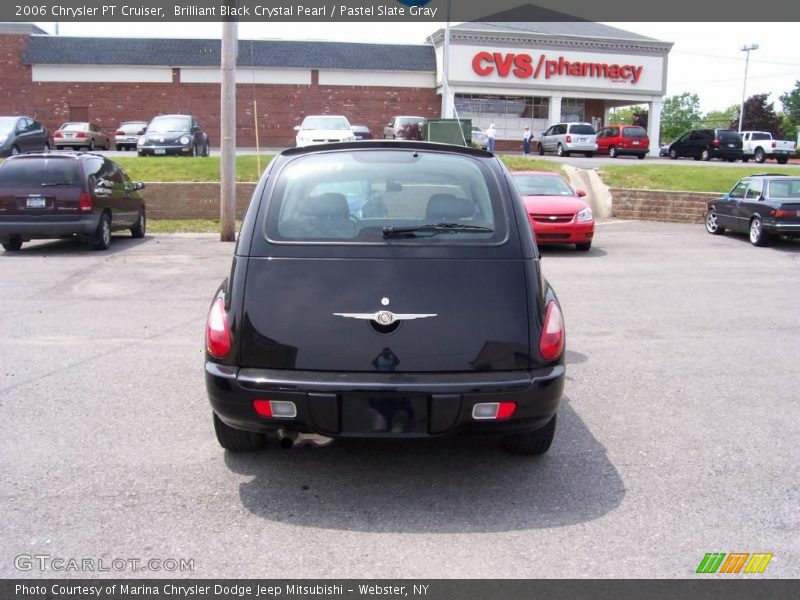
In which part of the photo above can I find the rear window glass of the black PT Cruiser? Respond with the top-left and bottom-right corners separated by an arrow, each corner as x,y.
266,149 -> 506,244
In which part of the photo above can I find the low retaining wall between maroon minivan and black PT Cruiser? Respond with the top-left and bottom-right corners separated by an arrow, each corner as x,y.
141,182 -> 256,219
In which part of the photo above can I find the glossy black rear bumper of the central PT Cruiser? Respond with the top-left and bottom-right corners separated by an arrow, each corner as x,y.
205,362 -> 565,437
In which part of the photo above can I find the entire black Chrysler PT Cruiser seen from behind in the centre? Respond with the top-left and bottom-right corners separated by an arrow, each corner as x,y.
205,141 -> 565,454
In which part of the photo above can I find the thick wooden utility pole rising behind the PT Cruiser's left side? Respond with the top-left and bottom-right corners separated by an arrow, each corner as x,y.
219,18 -> 238,242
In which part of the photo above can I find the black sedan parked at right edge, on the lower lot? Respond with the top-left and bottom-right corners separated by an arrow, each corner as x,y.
706,174 -> 800,246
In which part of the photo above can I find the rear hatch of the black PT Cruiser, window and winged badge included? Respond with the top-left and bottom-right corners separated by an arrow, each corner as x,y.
240,150 -> 530,372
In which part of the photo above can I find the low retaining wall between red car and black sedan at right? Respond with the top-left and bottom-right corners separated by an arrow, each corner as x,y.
610,188 -> 722,223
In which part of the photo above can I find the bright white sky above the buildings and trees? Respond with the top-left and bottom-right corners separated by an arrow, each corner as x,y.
32,22 -> 800,112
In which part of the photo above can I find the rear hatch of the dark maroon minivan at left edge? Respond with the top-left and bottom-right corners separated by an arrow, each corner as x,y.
0,155 -> 83,221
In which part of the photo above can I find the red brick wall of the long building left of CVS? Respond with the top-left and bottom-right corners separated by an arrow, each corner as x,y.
0,35 -> 441,147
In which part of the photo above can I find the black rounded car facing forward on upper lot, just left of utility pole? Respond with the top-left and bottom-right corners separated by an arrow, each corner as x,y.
136,115 -> 211,156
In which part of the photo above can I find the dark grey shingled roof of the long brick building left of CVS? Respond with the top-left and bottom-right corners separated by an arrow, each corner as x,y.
22,35 -> 436,72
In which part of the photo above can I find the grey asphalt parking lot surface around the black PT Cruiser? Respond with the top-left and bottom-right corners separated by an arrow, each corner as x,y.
0,221 -> 800,578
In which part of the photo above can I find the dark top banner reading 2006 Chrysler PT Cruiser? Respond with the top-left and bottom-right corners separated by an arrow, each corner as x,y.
0,0 -> 800,22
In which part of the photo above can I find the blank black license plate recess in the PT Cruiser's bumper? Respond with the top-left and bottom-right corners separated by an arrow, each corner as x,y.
340,393 -> 428,436
